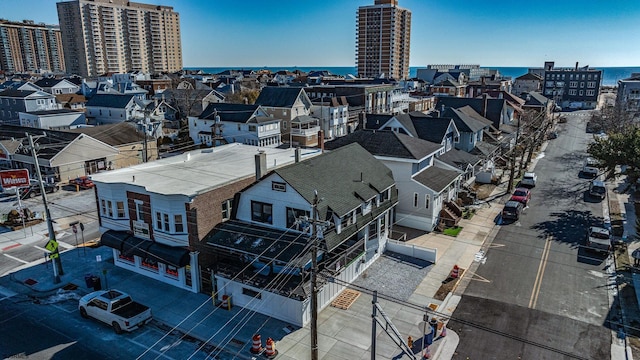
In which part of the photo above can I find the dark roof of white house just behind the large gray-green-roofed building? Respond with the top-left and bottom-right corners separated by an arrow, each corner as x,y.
324,130 -> 442,160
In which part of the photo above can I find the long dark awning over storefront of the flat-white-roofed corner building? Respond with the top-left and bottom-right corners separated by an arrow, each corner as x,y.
100,230 -> 190,267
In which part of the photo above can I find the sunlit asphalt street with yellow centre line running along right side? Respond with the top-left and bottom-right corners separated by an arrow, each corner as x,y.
449,111 -> 614,359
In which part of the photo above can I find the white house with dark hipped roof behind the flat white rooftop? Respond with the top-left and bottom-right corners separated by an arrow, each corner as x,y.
189,103 -> 282,147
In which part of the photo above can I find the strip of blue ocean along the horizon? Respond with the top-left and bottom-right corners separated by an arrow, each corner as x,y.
185,66 -> 640,86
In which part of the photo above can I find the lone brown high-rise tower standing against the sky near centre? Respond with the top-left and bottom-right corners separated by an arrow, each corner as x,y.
356,0 -> 411,80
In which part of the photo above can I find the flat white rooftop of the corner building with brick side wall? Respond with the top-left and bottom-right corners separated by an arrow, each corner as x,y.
91,143 -> 321,197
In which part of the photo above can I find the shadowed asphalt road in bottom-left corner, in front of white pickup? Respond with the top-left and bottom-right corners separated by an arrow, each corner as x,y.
0,289 -> 215,360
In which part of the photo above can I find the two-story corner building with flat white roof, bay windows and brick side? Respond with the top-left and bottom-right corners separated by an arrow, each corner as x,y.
92,143 -> 319,294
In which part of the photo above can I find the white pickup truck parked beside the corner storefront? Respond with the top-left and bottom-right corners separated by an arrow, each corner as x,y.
78,290 -> 152,334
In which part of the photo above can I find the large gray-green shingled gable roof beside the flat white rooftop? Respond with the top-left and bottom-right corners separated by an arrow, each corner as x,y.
274,143 -> 395,218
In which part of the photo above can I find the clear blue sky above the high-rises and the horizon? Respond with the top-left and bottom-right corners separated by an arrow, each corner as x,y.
0,0 -> 640,67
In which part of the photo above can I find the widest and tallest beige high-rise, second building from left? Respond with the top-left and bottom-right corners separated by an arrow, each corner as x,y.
57,0 -> 182,76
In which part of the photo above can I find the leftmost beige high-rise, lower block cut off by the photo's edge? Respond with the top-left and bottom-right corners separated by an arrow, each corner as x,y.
0,19 -> 65,73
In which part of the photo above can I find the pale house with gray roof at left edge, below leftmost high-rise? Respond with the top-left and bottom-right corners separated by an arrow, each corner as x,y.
0,89 -> 59,125
